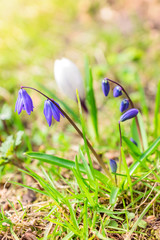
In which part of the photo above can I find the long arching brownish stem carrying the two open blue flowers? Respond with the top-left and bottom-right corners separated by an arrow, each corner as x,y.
21,86 -> 113,181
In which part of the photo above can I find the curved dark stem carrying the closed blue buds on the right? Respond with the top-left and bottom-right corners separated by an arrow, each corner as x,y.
105,78 -> 144,151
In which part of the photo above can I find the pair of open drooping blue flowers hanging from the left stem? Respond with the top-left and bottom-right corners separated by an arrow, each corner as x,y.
15,88 -> 64,127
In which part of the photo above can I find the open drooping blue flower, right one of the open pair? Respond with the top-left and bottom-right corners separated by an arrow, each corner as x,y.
43,99 -> 64,127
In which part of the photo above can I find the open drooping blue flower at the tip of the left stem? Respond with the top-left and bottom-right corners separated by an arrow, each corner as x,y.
15,88 -> 34,115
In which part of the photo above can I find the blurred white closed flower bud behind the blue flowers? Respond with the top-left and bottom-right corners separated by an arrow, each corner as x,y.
54,58 -> 85,101
